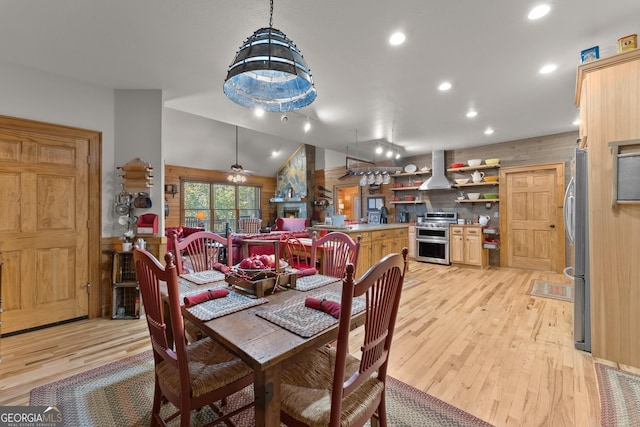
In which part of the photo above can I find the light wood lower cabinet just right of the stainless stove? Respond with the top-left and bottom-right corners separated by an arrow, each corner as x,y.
449,225 -> 489,268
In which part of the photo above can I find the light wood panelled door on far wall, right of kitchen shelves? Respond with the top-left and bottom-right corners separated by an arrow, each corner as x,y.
500,163 -> 565,273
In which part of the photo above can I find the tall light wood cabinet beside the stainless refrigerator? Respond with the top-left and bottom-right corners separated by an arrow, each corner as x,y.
576,49 -> 640,367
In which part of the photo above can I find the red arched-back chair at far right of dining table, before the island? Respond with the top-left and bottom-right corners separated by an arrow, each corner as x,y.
311,231 -> 362,279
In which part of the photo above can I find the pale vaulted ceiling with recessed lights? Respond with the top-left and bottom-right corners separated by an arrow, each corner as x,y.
0,0 -> 640,173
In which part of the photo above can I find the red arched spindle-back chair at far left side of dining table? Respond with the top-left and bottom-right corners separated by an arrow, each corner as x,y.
171,231 -> 232,274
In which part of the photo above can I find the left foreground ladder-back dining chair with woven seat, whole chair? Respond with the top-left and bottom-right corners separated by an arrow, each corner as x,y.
133,248 -> 253,427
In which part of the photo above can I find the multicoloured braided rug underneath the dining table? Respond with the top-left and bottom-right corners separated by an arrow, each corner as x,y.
29,351 -> 490,427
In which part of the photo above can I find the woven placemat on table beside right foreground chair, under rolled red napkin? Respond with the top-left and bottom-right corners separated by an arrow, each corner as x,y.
256,291 -> 365,338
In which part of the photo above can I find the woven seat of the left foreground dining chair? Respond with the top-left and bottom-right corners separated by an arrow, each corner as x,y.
156,337 -> 251,397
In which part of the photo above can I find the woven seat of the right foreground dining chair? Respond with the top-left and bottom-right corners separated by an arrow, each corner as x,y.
281,347 -> 384,427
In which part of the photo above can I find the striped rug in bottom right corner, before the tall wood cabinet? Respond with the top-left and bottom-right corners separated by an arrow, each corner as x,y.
595,363 -> 640,427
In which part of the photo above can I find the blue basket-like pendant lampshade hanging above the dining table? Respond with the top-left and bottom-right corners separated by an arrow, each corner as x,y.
224,27 -> 316,112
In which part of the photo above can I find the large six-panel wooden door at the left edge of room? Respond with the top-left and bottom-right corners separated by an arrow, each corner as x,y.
0,119 -> 99,333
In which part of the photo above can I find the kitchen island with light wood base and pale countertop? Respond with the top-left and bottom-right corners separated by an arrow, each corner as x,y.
308,223 -> 409,277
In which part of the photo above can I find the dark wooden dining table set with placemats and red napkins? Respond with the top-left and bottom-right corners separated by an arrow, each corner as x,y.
183,279 -> 365,427
